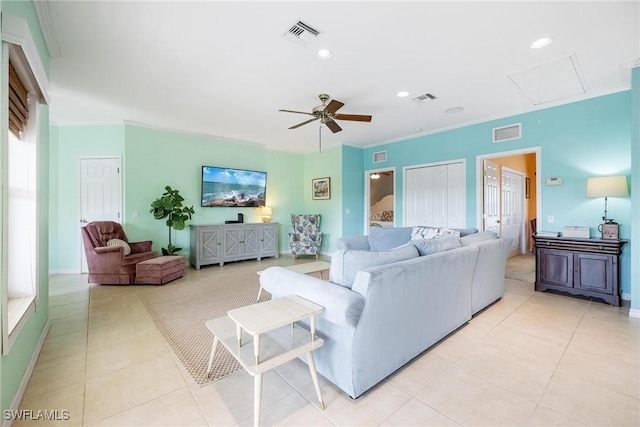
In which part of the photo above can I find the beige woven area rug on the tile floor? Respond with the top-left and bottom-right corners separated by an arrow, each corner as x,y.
137,267 -> 271,385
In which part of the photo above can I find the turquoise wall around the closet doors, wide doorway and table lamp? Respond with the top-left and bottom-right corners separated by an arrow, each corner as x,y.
364,91 -> 632,294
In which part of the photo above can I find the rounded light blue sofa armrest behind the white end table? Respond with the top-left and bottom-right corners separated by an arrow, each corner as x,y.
260,267 -> 364,328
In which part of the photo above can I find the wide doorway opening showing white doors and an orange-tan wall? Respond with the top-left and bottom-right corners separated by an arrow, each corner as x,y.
476,147 -> 542,257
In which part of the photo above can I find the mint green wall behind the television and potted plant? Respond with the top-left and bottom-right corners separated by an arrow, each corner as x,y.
125,126 -> 304,257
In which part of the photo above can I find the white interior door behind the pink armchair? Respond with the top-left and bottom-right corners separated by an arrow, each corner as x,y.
80,157 -> 122,273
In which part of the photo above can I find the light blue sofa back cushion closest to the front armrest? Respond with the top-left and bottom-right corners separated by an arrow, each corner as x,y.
329,244 -> 419,289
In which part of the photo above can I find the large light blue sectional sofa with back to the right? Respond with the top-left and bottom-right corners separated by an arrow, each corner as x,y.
260,229 -> 511,398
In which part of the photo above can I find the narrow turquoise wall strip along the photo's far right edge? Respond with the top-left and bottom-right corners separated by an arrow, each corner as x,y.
629,67 -> 640,317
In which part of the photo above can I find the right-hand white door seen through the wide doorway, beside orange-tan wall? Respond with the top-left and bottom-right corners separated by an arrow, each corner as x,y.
501,167 -> 524,257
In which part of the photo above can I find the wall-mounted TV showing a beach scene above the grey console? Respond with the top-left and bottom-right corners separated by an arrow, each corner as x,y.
202,166 -> 267,208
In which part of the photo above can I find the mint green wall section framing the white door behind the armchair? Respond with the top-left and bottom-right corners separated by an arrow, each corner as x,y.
50,125 -> 124,273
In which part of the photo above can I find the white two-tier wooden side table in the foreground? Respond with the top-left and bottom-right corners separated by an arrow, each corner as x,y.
206,295 -> 324,426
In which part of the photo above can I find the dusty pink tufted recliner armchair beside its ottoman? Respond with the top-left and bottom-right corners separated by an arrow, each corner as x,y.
82,221 -> 158,285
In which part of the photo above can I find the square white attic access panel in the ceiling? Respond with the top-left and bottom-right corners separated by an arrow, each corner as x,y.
507,55 -> 586,105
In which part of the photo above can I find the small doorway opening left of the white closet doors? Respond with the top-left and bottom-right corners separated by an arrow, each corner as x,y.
364,168 -> 396,234
